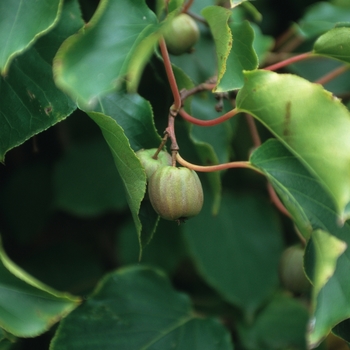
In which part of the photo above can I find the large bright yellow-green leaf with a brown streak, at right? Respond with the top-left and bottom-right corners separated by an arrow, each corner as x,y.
237,70 -> 350,219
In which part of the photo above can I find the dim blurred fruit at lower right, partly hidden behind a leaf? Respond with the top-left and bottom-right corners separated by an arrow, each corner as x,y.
280,246 -> 310,294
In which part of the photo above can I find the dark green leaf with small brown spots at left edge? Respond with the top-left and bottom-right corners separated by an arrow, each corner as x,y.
0,1 -> 82,161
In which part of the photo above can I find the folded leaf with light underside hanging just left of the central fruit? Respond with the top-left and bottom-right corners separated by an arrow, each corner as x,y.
88,91 -> 161,246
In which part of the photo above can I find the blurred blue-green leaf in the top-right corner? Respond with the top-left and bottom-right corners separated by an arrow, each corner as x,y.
297,1 -> 350,39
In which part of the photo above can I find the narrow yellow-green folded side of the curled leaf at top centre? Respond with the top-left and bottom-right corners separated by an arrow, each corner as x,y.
202,6 -> 232,88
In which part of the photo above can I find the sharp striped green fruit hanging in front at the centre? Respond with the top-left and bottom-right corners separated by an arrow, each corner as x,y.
148,166 -> 203,222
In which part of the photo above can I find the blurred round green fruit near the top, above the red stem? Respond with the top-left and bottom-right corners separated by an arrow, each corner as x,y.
163,13 -> 199,55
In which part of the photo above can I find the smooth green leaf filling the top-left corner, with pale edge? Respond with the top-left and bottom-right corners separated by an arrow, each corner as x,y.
0,0 -> 63,75
